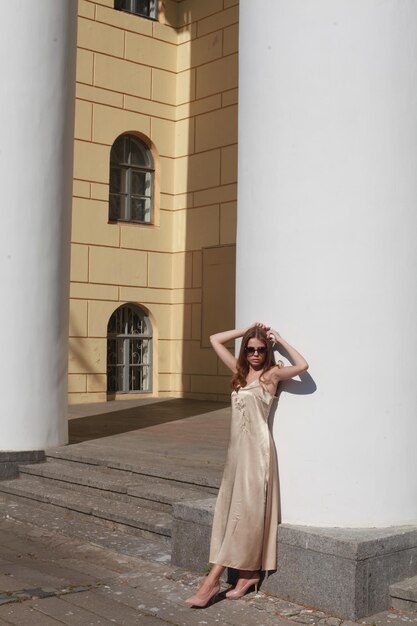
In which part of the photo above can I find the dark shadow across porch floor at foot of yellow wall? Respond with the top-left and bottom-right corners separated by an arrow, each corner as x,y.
68,398 -> 228,444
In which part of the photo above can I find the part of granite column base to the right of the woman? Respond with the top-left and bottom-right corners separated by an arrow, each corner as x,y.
264,524 -> 417,620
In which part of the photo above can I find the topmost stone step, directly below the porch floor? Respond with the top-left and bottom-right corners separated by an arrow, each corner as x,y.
46,444 -> 223,490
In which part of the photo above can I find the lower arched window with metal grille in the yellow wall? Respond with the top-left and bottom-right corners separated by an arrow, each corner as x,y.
107,304 -> 152,393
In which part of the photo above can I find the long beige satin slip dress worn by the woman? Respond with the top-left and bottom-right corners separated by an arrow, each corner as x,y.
210,380 -> 278,571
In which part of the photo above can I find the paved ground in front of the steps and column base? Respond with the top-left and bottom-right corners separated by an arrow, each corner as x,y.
0,518 -> 417,626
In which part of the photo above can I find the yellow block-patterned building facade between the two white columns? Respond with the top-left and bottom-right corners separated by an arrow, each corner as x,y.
69,0 -> 238,403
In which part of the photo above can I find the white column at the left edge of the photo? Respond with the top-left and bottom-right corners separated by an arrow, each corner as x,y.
0,0 -> 77,451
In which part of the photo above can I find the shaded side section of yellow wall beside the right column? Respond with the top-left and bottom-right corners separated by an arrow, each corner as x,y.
167,0 -> 238,401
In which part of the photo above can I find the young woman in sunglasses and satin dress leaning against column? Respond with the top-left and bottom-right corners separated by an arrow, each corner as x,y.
186,323 -> 308,607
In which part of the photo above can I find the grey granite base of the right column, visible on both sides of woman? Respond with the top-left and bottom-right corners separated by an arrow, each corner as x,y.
171,498 -> 417,620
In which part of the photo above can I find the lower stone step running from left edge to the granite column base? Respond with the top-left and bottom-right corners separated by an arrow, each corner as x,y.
0,475 -> 172,537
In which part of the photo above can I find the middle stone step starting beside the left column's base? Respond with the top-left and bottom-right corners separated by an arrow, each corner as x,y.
20,459 -> 216,512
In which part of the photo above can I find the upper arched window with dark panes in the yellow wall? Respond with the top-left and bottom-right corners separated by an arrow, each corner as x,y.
109,135 -> 155,224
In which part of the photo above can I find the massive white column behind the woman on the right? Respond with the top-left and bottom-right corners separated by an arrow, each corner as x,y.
237,0 -> 417,527
